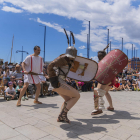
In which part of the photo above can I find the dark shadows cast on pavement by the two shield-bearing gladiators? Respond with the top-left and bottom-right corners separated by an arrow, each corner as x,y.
60,110 -> 140,139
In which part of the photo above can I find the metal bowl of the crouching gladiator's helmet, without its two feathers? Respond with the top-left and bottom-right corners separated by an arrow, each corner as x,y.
65,46 -> 77,58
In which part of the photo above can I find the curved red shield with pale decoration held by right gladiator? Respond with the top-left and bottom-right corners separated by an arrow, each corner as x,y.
95,49 -> 128,85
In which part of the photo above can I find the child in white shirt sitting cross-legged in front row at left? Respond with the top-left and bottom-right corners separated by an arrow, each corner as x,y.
5,81 -> 18,101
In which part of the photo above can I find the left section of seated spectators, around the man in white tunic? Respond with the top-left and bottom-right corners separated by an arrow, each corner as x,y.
0,62 -> 52,101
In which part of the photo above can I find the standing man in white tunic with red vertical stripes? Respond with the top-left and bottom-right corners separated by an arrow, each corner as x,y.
17,46 -> 43,106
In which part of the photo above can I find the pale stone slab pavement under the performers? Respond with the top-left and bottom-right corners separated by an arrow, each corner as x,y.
0,91 -> 140,140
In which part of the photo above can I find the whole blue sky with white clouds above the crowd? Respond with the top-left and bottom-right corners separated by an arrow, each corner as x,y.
0,0 -> 140,62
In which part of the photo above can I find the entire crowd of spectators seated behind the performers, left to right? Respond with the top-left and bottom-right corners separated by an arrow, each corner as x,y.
0,62 -> 140,101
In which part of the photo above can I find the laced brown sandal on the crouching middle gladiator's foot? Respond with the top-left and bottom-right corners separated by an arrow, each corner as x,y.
57,102 -> 70,124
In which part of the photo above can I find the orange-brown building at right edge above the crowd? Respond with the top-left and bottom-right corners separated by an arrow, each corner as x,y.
128,57 -> 140,70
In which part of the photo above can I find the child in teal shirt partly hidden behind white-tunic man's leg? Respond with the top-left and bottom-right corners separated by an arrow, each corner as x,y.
16,80 -> 28,101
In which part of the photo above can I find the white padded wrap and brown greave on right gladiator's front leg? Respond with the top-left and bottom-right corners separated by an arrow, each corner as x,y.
92,88 -> 106,112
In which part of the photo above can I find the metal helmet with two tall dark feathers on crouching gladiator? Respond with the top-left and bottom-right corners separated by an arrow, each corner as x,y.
64,29 -> 77,58
